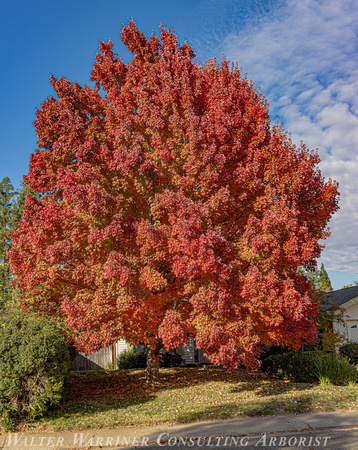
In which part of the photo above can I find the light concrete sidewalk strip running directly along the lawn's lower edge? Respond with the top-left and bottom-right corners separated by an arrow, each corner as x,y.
0,410 -> 358,450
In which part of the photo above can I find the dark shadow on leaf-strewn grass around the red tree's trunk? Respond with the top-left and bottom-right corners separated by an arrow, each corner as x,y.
56,368 -> 312,408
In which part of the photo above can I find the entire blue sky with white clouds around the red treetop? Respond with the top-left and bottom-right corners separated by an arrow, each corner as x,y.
0,0 -> 358,289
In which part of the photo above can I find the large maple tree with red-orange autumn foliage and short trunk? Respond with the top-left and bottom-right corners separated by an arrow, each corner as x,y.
9,21 -> 338,381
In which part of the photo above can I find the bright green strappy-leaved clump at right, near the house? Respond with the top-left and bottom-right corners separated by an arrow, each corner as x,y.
313,353 -> 358,385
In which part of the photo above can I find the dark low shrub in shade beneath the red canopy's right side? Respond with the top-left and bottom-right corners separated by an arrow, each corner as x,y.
261,352 -> 318,383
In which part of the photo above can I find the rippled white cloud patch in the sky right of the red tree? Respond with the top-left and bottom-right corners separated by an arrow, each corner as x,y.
222,0 -> 358,272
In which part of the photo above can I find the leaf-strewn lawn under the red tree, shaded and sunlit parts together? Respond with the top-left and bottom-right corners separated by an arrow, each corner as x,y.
27,368 -> 358,431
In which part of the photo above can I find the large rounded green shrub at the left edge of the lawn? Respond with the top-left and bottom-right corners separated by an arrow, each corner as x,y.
0,305 -> 70,429
